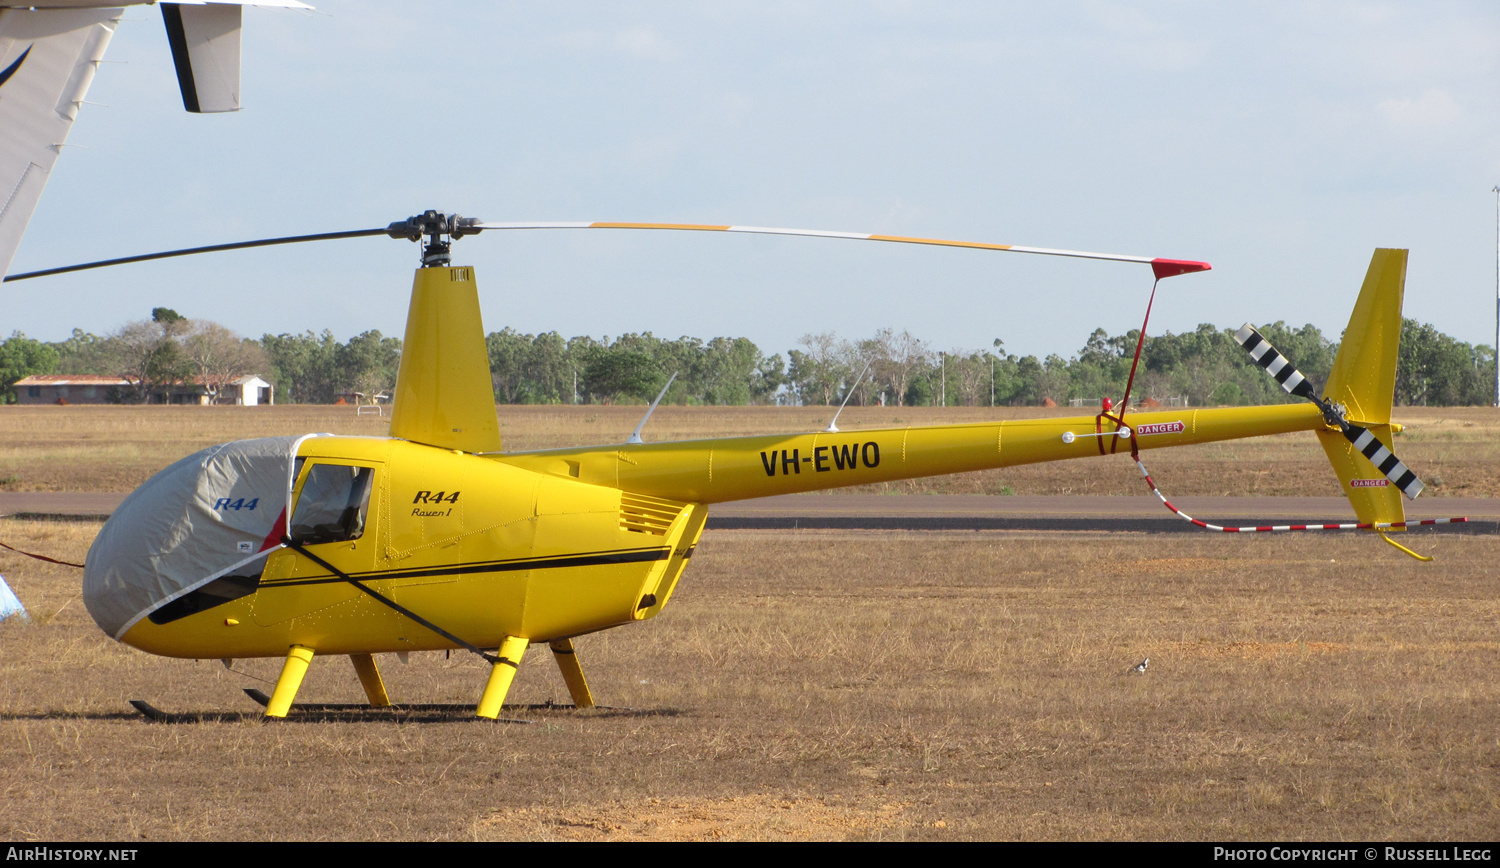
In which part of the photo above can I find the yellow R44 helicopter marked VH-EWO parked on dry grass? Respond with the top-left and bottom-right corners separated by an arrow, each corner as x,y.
8,211 -> 1440,718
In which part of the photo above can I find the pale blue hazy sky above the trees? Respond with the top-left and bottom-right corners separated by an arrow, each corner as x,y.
0,0 -> 1500,357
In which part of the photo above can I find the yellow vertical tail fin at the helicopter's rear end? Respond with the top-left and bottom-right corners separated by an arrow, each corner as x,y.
1317,249 -> 1407,523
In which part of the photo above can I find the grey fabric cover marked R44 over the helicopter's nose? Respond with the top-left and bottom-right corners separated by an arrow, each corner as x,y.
84,436 -> 306,639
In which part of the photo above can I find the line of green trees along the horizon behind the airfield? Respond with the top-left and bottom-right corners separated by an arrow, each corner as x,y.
0,307 -> 1496,406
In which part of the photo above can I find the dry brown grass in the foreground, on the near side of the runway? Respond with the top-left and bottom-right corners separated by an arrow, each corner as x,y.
0,520 -> 1500,841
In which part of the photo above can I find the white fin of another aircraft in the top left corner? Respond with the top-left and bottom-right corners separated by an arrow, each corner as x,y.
0,7 -> 123,273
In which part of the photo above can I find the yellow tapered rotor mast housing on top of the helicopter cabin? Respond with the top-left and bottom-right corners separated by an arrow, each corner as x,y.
390,265 -> 500,453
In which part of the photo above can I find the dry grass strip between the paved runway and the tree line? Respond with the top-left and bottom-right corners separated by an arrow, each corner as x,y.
0,406 -> 1500,496
